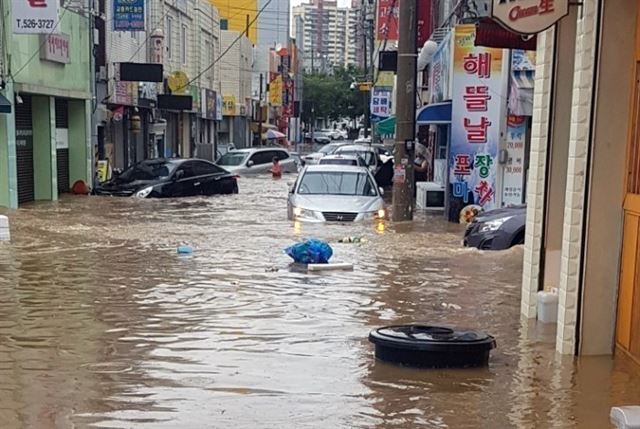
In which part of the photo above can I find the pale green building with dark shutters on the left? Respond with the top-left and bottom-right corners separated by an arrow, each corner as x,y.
0,2 -> 93,208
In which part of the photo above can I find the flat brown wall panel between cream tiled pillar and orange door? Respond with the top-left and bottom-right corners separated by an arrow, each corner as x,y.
579,0 -> 638,355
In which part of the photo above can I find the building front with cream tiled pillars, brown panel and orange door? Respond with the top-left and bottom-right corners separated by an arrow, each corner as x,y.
521,0 -> 640,363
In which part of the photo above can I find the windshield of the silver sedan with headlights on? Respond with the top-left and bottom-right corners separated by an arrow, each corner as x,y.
298,171 -> 378,197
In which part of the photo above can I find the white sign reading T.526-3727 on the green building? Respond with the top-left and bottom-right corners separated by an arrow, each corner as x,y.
12,0 -> 59,34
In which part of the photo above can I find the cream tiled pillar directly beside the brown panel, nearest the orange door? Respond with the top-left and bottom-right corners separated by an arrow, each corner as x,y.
556,1 -> 604,354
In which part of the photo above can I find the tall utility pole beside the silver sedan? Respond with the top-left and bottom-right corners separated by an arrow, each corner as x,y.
392,0 -> 418,221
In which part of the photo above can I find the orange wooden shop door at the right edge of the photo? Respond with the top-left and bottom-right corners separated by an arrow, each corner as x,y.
616,10 -> 640,363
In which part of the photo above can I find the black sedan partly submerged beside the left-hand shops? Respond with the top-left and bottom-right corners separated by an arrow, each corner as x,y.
94,158 -> 238,198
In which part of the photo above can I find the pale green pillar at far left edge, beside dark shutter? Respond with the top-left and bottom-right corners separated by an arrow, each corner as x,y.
0,79 -> 18,209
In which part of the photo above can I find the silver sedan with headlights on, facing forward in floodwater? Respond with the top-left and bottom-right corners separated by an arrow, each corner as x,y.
287,165 -> 387,222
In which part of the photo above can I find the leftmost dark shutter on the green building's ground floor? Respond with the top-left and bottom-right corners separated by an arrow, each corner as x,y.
16,95 -> 35,204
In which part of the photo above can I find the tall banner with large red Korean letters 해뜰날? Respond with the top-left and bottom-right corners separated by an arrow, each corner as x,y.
449,25 -> 506,221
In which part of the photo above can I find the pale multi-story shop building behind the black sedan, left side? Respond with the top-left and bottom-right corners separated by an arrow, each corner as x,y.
95,0 -> 220,168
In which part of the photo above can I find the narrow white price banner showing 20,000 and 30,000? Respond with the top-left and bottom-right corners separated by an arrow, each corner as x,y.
502,115 -> 527,206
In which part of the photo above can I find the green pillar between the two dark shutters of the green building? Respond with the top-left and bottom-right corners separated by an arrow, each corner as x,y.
31,95 -> 58,200
